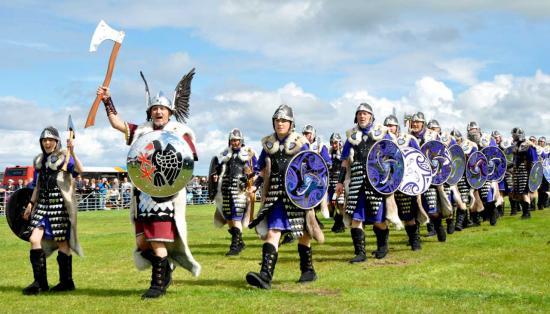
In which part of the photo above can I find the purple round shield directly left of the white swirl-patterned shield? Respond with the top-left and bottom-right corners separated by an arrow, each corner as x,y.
367,140 -> 405,195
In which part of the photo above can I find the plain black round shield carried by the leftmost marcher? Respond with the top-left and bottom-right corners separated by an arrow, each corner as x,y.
6,188 -> 32,241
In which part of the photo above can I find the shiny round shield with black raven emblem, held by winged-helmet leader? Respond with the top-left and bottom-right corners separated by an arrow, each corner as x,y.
126,131 -> 194,197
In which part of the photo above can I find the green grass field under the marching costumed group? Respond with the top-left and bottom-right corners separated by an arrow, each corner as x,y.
0,205 -> 550,313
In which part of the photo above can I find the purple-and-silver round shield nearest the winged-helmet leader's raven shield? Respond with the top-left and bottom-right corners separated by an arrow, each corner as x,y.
285,151 -> 328,209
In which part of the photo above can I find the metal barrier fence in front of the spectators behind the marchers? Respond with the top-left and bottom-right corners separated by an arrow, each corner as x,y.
0,188 -> 216,215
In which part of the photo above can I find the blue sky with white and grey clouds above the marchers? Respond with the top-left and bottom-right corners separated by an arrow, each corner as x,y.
0,0 -> 550,173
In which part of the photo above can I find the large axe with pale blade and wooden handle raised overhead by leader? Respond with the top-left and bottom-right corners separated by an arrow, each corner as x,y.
84,20 -> 124,128
